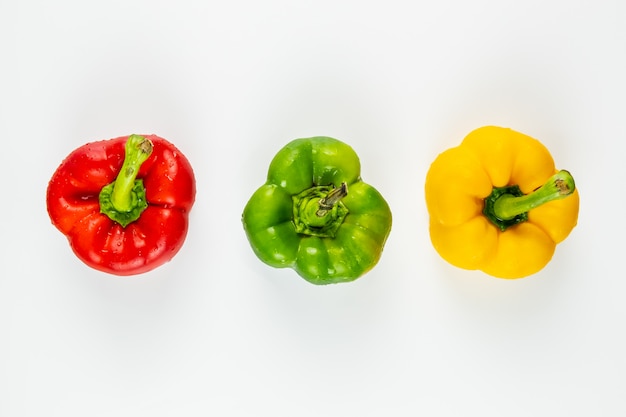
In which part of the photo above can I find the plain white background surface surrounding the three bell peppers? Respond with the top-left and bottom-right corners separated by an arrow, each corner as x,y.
0,0 -> 626,417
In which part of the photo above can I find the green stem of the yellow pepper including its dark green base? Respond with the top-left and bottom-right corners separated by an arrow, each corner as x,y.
483,170 -> 576,231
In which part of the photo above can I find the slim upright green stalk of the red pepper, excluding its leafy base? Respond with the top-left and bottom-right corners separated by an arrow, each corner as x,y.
111,135 -> 152,212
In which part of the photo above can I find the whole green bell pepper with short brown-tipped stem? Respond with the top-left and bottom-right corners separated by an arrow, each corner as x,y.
242,137 -> 391,285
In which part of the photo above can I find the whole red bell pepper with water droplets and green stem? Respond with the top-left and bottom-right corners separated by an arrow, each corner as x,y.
46,135 -> 196,275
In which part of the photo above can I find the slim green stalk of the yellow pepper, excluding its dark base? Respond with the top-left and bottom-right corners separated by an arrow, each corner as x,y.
493,170 -> 576,220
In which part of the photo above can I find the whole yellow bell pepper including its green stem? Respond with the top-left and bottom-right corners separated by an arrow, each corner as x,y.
425,126 -> 579,278
